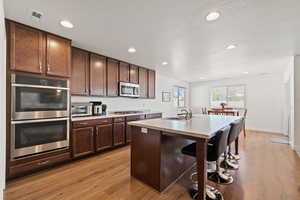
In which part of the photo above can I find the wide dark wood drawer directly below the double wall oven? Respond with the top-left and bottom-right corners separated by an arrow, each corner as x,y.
9,152 -> 71,177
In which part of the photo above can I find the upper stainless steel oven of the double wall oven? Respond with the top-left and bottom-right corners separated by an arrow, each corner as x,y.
11,74 -> 70,120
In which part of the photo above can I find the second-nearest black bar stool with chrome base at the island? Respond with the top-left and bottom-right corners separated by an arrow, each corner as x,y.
221,119 -> 244,170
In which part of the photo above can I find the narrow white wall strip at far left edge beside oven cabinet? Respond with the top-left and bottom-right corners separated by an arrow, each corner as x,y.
0,0 -> 6,199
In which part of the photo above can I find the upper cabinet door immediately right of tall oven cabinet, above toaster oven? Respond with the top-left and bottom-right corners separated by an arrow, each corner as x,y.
71,48 -> 89,95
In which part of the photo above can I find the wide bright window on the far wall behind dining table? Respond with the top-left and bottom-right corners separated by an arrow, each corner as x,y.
210,85 -> 246,108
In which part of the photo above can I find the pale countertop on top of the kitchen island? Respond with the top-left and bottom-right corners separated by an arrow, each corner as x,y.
128,115 -> 242,138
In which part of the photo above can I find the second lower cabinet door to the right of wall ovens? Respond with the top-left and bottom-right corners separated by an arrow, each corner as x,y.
96,124 -> 113,151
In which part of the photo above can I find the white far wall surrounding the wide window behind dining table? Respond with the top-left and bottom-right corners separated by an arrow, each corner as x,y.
190,73 -> 287,134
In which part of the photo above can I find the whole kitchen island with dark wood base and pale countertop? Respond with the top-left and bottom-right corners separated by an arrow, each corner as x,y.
129,115 -> 241,200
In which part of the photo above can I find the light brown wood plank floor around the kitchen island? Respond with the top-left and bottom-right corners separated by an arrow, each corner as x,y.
5,132 -> 300,200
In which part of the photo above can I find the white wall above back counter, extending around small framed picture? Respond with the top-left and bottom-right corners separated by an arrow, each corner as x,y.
72,71 -> 189,117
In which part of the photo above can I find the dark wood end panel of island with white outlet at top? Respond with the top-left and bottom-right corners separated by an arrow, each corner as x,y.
131,126 -> 161,191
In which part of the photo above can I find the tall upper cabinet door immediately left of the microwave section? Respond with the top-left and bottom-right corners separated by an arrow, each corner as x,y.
107,59 -> 119,96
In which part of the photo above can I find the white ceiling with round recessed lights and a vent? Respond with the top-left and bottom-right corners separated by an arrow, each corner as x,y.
4,0 -> 300,82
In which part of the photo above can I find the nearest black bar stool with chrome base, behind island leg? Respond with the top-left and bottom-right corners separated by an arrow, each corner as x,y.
181,126 -> 233,200
